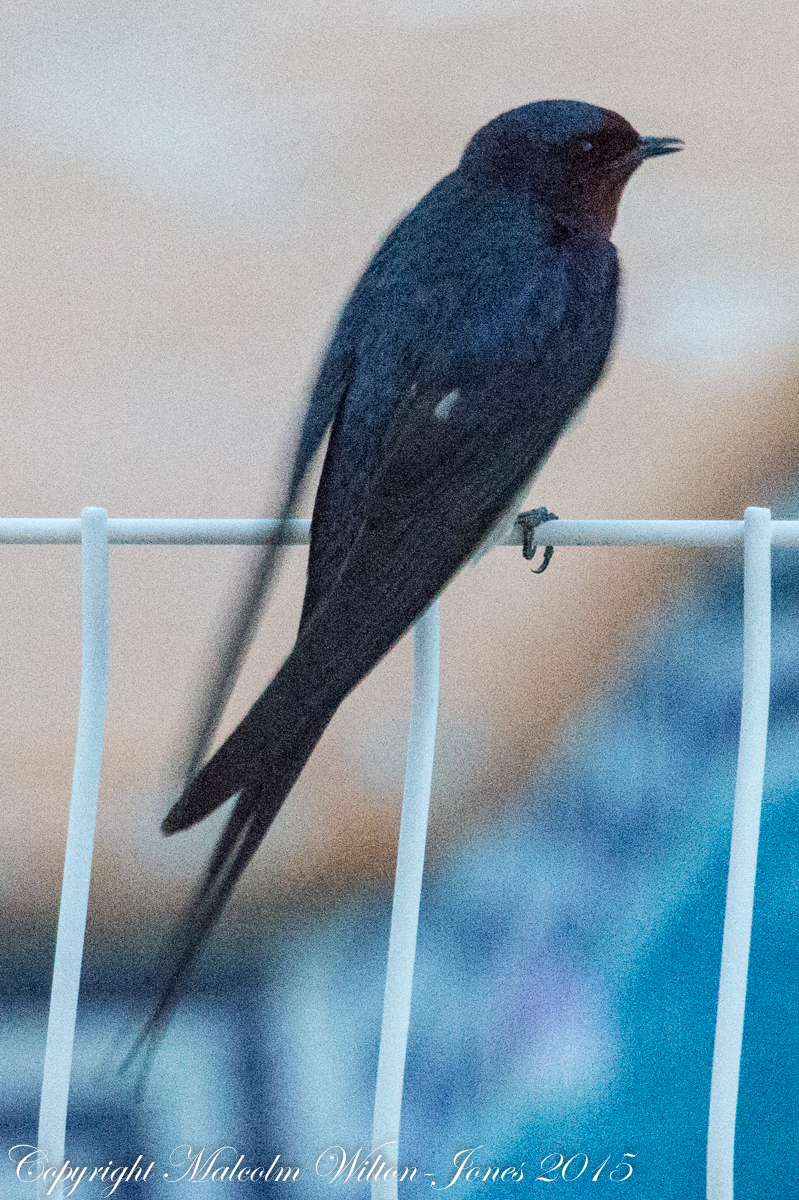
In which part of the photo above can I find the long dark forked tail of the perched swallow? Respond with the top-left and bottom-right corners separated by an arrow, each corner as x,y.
121,656 -> 337,1092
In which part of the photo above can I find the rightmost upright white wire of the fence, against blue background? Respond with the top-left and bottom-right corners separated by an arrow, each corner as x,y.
708,508 -> 771,1200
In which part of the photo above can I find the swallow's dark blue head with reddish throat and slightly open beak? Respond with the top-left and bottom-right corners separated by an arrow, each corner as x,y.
459,100 -> 683,238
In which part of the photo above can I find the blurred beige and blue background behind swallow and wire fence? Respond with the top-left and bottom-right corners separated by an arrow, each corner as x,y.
0,0 -> 799,1198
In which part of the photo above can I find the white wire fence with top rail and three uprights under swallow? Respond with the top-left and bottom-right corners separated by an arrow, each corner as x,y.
0,508 -> 782,1200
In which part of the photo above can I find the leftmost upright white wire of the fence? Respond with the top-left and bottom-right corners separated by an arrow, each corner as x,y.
38,508 -> 108,1187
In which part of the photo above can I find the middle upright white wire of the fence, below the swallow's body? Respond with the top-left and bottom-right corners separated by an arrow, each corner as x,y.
372,600 -> 439,1200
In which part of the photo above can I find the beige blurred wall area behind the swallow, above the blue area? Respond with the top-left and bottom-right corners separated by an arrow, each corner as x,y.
0,0 -> 799,922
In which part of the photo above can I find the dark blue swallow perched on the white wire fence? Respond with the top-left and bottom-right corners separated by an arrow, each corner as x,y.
143,100 -> 683,1039
